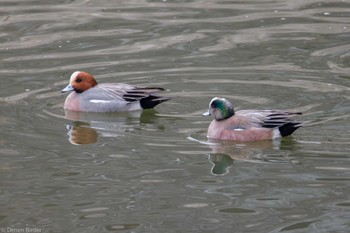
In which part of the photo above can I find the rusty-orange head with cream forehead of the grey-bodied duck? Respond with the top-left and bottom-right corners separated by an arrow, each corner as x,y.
61,71 -> 97,93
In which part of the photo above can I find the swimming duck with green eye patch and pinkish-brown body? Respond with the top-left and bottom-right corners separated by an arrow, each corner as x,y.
203,97 -> 302,141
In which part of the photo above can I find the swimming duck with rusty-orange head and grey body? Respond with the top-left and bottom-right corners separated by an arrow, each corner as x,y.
62,71 -> 170,112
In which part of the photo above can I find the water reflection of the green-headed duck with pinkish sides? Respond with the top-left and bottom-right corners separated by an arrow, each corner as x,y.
208,138 -> 295,175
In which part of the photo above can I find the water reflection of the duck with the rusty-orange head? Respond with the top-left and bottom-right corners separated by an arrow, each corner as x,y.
65,110 -> 157,145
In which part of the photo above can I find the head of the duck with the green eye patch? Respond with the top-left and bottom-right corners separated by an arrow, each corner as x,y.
203,97 -> 235,121
